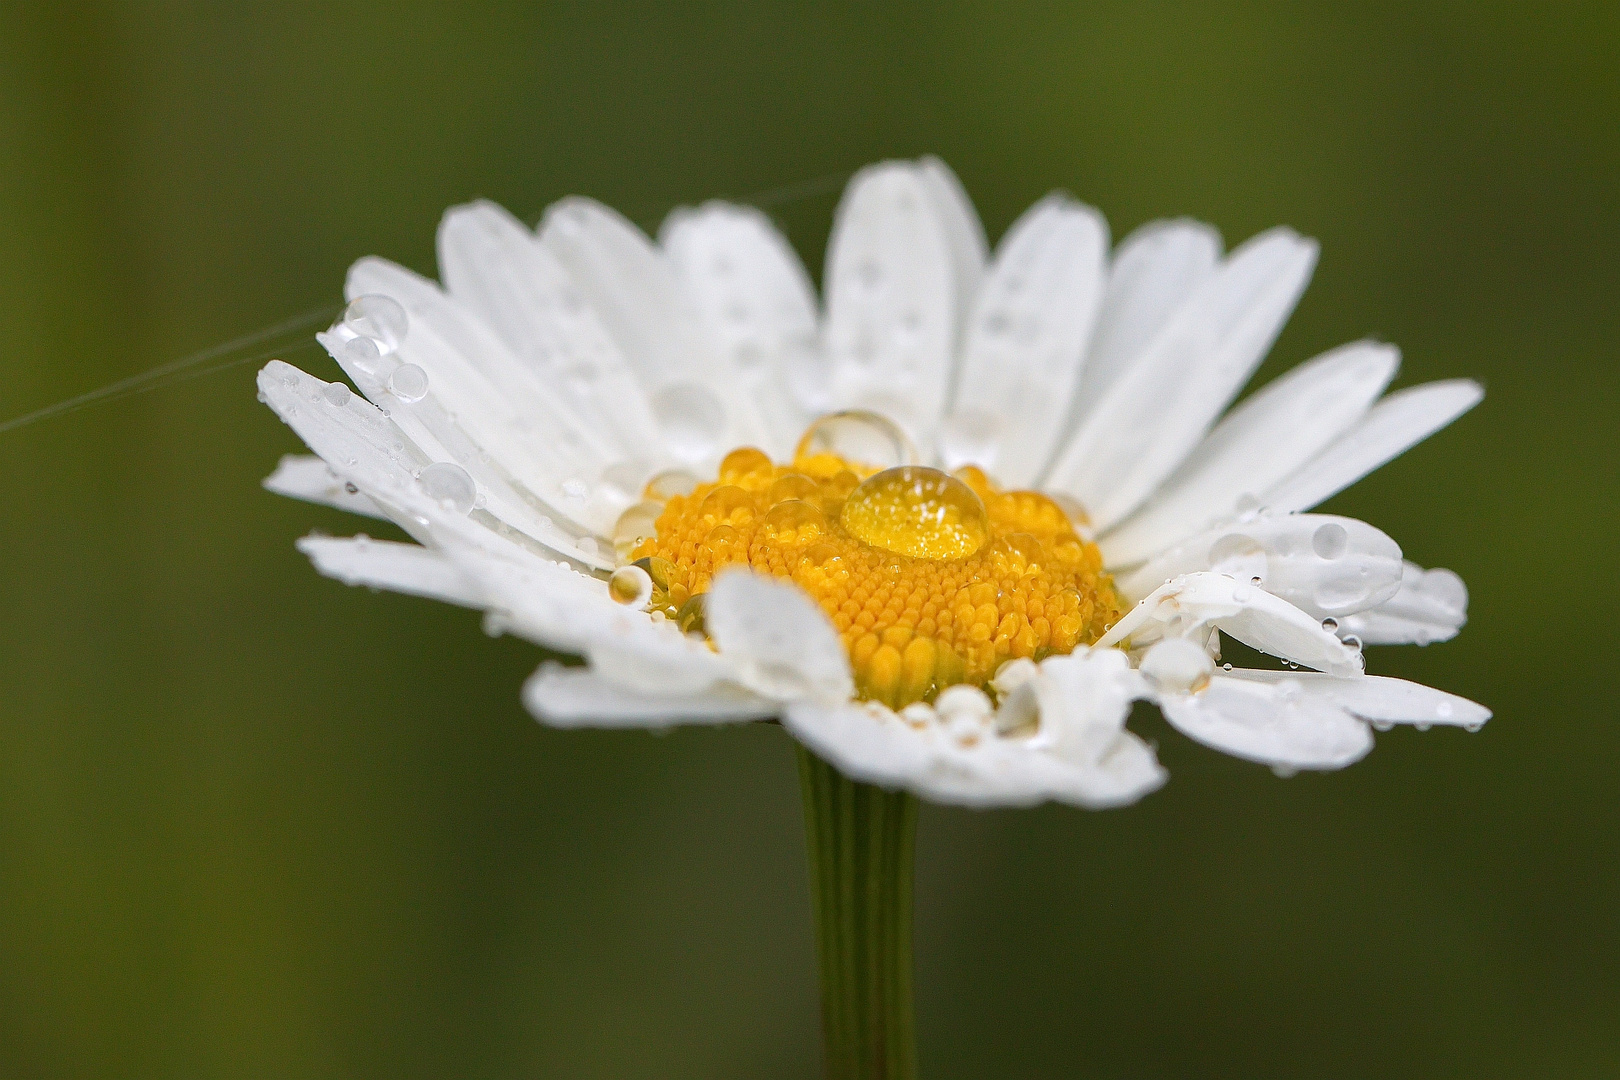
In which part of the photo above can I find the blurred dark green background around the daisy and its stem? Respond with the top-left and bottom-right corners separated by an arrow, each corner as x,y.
0,0 -> 1620,1080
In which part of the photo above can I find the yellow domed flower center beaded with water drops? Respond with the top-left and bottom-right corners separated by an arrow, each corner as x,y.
619,420 -> 1123,708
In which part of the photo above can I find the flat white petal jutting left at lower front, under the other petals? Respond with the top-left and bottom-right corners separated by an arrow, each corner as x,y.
523,665 -> 778,727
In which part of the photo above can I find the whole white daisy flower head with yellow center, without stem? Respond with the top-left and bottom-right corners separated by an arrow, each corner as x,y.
259,159 -> 1489,806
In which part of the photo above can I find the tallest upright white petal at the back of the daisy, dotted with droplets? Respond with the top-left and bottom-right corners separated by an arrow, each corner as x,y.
826,162 -> 957,447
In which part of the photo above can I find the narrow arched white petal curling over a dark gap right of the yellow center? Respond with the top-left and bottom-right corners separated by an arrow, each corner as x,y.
1097,573 -> 1362,675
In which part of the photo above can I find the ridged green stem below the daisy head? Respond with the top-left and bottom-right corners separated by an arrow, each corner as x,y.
799,746 -> 917,1080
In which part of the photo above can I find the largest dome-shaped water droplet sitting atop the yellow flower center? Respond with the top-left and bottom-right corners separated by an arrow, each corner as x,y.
841,465 -> 990,559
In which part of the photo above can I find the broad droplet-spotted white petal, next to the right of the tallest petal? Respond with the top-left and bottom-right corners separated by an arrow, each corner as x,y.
940,196 -> 1108,486
